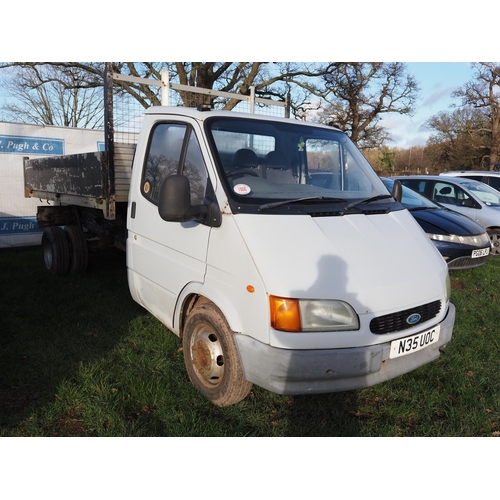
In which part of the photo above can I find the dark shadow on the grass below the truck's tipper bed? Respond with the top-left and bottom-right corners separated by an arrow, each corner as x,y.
0,247 -> 144,431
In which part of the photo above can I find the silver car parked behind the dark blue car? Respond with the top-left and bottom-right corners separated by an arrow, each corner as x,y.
392,175 -> 500,255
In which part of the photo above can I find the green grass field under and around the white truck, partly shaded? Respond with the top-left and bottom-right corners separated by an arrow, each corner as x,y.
0,248 -> 500,436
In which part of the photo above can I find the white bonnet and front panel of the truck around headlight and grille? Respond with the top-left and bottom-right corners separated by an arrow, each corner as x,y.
235,210 -> 447,349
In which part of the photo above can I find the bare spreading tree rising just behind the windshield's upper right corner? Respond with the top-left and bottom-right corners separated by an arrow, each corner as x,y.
312,62 -> 419,148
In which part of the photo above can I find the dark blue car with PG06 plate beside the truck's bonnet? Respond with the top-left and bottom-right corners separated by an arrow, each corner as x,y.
381,177 -> 491,270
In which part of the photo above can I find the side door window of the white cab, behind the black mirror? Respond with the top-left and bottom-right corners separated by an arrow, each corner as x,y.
142,123 -> 208,205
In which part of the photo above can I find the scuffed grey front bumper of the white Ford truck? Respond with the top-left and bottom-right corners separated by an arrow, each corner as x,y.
234,303 -> 455,394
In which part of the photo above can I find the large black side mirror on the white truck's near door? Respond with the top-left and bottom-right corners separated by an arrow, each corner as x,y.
158,175 -> 222,227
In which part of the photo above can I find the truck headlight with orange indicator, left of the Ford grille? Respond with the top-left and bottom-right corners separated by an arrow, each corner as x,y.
270,295 -> 359,332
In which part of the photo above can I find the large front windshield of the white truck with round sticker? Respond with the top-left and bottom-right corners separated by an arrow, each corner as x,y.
206,117 -> 394,212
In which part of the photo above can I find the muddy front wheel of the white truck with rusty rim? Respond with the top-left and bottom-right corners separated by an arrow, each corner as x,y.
182,302 -> 253,406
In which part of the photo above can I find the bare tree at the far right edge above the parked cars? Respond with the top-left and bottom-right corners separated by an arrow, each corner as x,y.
453,62 -> 500,169
